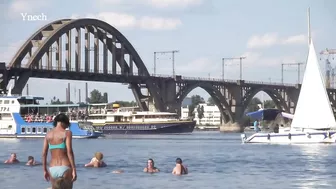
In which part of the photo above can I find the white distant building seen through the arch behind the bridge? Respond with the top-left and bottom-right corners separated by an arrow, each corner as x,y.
181,103 -> 222,125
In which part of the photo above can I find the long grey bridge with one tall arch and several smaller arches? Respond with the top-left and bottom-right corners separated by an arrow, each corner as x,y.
0,19 -> 336,130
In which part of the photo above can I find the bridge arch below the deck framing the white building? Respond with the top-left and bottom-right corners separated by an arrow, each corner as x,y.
176,82 -> 234,123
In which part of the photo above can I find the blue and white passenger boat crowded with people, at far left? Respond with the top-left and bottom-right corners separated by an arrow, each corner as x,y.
0,90 -> 102,138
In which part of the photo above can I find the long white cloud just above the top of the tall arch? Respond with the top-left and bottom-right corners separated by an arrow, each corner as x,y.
71,12 -> 182,30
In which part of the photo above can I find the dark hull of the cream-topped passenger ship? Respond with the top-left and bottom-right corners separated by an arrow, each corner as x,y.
96,121 -> 196,135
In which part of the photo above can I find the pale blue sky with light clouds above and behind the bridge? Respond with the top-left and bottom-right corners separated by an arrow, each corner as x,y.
0,0 -> 336,102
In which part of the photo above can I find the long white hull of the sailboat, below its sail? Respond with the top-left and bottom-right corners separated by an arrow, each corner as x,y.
241,131 -> 336,144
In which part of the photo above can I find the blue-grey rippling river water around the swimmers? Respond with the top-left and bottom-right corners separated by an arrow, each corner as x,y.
0,132 -> 336,189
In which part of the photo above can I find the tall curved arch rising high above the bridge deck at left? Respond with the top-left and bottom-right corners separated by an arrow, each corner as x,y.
9,18 -> 165,111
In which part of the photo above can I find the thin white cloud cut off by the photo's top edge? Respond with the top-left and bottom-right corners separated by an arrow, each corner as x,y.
146,0 -> 202,8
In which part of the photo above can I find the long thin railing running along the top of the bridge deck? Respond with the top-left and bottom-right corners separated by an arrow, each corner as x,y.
7,66 -> 296,87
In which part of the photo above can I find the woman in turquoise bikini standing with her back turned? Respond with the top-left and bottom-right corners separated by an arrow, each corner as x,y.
42,114 -> 77,189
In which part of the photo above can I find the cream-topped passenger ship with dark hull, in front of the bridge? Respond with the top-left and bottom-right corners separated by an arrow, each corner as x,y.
87,103 -> 196,134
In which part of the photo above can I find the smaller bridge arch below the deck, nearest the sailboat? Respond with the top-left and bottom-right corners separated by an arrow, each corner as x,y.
243,87 -> 290,112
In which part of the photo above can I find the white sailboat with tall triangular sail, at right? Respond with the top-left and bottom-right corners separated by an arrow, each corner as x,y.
241,40 -> 336,143
